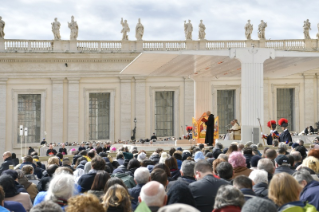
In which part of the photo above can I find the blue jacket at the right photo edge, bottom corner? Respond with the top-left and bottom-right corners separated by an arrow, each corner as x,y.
300,180 -> 319,210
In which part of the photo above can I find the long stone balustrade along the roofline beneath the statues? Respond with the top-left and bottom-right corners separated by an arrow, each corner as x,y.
0,39 -> 319,52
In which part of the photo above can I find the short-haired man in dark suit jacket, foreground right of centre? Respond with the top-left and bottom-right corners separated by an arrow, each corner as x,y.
189,160 -> 229,212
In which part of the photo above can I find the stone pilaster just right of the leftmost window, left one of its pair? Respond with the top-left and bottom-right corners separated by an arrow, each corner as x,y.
48,78 -> 64,143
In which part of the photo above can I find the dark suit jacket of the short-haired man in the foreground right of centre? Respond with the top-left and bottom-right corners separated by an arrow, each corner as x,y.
189,174 -> 229,212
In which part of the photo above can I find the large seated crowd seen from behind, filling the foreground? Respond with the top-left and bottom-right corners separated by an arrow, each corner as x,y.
0,139 -> 319,212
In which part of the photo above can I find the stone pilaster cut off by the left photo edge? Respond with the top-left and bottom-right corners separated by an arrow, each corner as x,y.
0,78 -> 8,157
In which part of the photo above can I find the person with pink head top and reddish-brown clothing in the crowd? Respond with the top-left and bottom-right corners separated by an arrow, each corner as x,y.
228,152 -> 252,179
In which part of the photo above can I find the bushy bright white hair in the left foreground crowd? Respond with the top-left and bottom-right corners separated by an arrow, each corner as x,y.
45,172 -> 76,201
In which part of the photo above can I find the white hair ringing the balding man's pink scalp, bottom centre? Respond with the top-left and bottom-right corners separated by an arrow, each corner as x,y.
140,181 -> 166,206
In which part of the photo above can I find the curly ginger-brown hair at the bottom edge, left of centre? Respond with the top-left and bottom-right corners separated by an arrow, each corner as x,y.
65,194 -> 105,212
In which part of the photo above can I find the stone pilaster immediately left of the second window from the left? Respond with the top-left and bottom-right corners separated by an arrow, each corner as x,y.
67,77 -> 80,142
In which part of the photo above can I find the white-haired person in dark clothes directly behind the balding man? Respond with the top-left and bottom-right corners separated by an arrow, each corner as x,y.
128,167 -> 150,211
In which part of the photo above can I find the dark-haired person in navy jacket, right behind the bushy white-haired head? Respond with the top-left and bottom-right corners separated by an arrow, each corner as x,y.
78,155 -> 105,193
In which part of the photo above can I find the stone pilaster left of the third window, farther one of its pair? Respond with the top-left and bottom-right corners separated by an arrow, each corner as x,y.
120,76 -> 132,140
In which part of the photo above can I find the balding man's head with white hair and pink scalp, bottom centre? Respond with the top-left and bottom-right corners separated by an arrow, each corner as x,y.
138,181 -> 167,207
